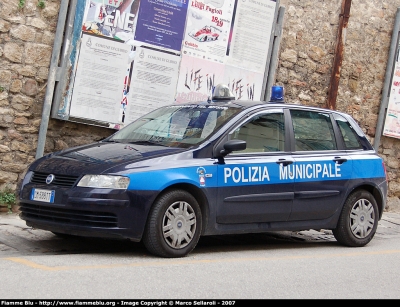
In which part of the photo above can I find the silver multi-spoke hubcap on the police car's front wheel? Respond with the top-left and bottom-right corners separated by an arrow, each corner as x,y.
162,201 -> 196,249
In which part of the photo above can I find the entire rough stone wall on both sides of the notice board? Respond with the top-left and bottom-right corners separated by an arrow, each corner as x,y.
0,0 -> 400,202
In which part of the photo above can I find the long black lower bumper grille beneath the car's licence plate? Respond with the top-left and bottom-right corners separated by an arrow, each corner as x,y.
20,203 -> 117,228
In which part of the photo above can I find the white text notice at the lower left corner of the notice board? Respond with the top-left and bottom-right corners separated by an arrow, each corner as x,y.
70,34 -> 131,123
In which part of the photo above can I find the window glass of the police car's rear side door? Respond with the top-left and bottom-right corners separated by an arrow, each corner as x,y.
290,110 -> 337,151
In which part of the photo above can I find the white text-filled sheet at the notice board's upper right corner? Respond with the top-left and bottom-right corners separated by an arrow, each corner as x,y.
225,0 -> 276,73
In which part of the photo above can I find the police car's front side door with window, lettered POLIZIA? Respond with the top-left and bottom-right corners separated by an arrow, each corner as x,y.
217,109 -> 294,224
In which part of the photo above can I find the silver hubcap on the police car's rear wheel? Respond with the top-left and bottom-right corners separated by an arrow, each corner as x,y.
350,199 -> 375,239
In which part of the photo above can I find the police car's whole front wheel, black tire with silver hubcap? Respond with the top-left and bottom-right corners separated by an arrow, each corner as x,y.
143,190 -> 202,258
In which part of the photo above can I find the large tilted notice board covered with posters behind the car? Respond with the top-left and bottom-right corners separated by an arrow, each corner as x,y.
52,0 -> 279,129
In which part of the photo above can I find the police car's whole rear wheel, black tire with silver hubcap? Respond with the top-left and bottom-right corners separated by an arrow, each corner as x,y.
332,190 -> 379,247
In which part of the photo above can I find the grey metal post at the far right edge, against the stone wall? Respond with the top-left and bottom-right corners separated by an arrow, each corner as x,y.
374,8 -> 400,151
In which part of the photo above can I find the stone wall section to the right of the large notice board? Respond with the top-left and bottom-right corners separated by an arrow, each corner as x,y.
276,0 -> 400,197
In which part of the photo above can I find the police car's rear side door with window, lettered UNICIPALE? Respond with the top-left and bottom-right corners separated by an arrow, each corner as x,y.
289,109 -> 352,221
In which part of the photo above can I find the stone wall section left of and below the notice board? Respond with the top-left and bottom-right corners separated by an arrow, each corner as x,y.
0,0 -> 111,197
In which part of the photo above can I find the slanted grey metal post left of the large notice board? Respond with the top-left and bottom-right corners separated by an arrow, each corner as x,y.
36,0 -> 69,159
